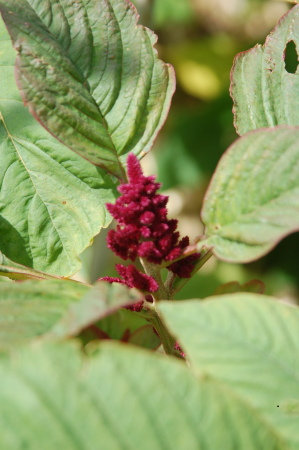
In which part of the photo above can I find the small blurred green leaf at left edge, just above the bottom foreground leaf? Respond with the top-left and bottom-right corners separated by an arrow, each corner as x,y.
0,280 -> 90,351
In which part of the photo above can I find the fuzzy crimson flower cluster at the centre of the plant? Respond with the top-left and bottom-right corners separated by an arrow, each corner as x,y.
103,153 -> 200,292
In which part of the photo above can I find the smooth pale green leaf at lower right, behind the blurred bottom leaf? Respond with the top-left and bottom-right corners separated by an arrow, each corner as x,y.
159,293 -> 299,450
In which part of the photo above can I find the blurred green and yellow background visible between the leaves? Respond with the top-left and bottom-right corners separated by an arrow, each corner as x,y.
78,0 -> 299,302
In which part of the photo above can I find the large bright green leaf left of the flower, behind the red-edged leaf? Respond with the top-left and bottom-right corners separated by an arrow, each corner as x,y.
0,21 -> 115,276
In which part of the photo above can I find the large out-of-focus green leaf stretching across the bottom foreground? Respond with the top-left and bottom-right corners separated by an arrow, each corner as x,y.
0,343 -> 290,450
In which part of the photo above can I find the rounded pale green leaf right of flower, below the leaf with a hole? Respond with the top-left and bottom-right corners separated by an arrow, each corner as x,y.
200,126 -> 299,262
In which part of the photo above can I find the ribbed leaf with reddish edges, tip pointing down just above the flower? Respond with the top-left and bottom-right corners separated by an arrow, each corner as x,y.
0,0 -> 174,178
